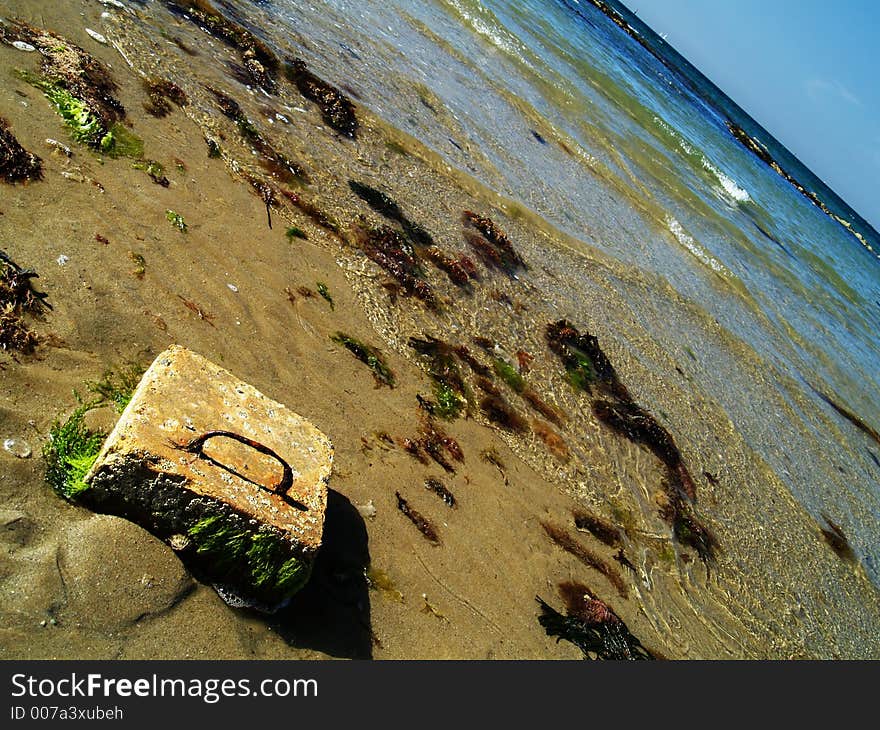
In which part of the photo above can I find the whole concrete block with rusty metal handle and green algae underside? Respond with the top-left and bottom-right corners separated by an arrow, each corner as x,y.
78,345 -> 333,607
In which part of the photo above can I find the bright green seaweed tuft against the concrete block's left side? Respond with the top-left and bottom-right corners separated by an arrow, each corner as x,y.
43,404 -> 104,500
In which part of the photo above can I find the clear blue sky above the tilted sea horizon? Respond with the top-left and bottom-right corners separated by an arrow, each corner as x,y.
624,0 -> 880,230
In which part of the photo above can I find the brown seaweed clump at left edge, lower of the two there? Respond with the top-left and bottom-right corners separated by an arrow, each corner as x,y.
0,251 -> 52,354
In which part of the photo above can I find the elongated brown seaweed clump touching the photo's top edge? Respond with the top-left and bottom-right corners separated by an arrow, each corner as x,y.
165,0 -> 280,94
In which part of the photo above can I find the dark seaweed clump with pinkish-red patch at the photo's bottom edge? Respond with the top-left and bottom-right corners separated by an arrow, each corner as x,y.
536,581 -> 656,661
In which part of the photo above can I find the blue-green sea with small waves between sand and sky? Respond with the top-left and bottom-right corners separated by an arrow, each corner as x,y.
251,0 -> 880,572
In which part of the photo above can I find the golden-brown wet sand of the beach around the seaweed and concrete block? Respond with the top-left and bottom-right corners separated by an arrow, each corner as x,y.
0,2 -> 880,659
